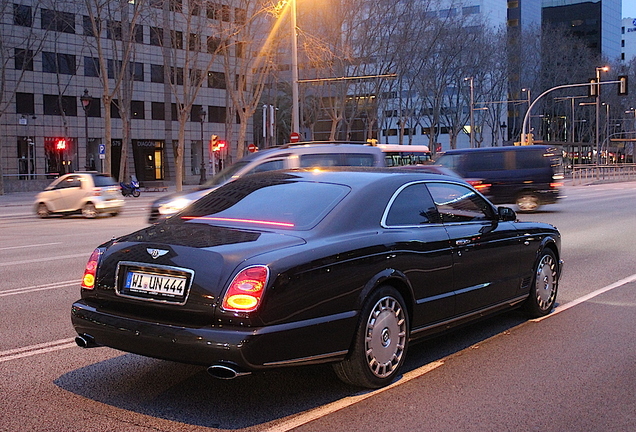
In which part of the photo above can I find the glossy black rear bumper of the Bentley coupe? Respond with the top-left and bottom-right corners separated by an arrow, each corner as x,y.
71,300 -> 357,371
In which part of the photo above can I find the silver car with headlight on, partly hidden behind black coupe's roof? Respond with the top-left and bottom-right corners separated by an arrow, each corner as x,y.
148,142 -> 385,223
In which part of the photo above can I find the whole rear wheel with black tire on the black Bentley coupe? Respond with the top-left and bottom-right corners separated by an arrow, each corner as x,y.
334,286 -> 410,388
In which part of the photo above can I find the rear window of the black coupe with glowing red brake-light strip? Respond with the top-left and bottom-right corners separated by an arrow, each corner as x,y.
180,175 -> 350,230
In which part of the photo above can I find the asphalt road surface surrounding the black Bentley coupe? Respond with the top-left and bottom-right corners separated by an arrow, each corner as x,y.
0,183 -> 636,432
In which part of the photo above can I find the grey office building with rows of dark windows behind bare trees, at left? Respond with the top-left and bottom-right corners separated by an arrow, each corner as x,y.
0,0 -> 252,192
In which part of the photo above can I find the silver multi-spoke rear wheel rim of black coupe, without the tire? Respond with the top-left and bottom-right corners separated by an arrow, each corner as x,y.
365,296 -> 407,378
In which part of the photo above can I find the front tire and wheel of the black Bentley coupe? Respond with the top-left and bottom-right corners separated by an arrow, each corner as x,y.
524,249 -> 559,318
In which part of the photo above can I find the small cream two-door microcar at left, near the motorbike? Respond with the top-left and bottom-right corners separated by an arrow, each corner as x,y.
34,172 -> 124,219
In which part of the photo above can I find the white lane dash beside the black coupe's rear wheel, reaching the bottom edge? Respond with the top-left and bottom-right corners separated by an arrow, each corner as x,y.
261,361 -> 444,432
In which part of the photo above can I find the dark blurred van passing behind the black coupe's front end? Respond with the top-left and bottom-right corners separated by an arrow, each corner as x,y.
435,145 -> 563,212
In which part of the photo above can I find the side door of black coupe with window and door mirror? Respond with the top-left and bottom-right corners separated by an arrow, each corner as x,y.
428,182 -> 523,315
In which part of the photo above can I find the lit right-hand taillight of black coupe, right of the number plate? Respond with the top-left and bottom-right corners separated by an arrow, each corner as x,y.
223,266 -> 269,312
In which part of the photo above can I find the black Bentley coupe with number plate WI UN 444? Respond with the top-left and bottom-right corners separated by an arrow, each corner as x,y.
72,168 -> 562,388
